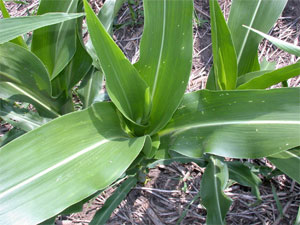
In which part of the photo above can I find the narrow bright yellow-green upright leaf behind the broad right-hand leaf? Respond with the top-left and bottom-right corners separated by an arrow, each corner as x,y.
209,0 -> 237,90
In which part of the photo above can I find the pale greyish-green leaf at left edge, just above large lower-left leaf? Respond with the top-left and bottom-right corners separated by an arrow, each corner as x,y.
0,99 -> 49,131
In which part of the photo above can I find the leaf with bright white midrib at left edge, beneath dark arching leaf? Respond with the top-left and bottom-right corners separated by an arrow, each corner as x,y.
0,82 -> 60,118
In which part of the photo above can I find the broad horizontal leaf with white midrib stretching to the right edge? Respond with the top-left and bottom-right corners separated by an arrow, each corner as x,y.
159,88 -> 300,158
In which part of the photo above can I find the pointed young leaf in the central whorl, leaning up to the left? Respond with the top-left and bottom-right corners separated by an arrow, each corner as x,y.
84,0 -> 150,124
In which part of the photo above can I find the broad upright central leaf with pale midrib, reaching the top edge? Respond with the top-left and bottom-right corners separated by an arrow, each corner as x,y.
135,0 -> 193,134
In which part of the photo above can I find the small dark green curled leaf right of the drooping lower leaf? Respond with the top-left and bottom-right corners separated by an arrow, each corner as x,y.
226,161 -> 262,200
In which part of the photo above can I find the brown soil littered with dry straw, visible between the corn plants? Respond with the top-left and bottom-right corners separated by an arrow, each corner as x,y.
0,0 -> 300,225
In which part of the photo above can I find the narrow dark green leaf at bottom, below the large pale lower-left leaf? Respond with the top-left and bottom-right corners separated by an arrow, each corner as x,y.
90,177 -> 137,225
